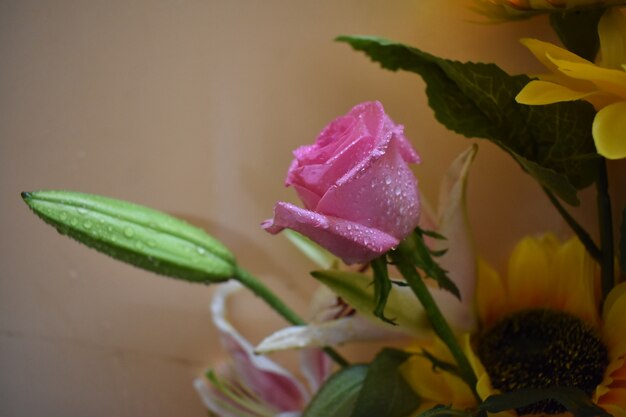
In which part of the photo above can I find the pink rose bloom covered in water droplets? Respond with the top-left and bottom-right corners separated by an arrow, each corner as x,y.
262,101 -> 420,264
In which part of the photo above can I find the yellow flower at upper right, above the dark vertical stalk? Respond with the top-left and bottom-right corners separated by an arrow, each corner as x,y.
516,8 -> 626,159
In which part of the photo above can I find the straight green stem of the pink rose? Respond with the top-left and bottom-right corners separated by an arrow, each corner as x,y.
389,242 -> 480,401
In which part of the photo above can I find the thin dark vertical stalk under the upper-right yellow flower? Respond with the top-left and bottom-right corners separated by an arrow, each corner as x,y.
596,158 -> 615,305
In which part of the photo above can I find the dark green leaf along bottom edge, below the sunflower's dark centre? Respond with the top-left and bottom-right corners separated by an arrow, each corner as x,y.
479,387 -> 611,417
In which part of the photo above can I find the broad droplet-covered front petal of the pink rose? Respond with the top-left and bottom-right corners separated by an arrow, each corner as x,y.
315,140 -> 420,240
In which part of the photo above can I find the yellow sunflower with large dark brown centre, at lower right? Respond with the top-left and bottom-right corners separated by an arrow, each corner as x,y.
403,235 -> 626,417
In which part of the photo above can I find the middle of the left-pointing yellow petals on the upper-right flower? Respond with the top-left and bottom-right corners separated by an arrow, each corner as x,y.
548,55 -> 626,100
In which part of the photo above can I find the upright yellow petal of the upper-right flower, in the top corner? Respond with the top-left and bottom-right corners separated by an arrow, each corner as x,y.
598,8 -> 626,69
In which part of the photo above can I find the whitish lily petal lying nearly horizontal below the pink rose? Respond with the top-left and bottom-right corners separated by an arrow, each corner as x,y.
255,315 -> 408,353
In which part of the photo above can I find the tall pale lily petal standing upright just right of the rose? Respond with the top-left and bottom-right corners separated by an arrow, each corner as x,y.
432,145 -> 478,331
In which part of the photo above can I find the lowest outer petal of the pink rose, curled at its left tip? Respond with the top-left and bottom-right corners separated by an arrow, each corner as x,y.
262,202 -> 399,264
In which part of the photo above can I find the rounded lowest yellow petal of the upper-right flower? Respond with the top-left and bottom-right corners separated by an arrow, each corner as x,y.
592,101 -> 626,159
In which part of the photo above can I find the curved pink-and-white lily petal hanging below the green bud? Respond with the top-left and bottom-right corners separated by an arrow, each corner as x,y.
211,281 -> 309,411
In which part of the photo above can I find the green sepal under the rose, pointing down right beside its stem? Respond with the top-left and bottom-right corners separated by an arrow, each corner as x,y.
404,227 -> 461,299
